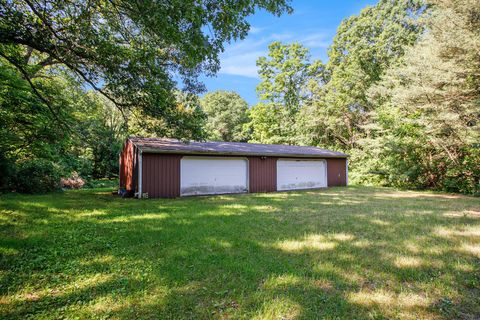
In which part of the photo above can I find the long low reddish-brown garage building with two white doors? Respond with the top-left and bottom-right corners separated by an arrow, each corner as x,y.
120,137 -> 348,198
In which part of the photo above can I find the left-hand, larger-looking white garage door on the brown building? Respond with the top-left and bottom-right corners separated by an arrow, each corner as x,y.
180,157 -> 248,196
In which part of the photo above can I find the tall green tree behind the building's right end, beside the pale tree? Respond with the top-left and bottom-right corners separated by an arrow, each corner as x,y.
305,0 -> 426,150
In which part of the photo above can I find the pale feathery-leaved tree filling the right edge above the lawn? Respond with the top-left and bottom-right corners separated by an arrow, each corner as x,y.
366,0 -> 480,193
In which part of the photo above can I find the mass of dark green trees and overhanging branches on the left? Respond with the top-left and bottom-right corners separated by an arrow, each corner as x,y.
0,0 -> 291,192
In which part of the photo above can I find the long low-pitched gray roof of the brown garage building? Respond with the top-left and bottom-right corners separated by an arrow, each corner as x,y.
130,137 -> 347,158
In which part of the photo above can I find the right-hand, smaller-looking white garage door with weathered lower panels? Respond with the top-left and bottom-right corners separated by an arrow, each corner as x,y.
277,159 -> 327,191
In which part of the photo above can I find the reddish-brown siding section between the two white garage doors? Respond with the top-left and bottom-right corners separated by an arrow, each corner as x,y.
248,157 -> 277,192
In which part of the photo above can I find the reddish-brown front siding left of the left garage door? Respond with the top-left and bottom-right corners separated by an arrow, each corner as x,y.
142,153 -> 182,198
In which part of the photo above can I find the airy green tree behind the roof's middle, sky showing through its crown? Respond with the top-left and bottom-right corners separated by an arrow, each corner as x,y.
248,42 -> 324,144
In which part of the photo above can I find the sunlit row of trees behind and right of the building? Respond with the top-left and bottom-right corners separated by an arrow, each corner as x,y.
203,0 -> 480,194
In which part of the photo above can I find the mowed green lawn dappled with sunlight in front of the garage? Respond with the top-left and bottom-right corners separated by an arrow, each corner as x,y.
0,187 -> 480,319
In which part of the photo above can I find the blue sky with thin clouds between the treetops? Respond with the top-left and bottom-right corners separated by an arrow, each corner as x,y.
202,0 -> 377,105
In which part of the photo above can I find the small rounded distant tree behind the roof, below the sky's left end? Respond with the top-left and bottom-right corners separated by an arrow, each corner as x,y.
200,91 -> 248,141
